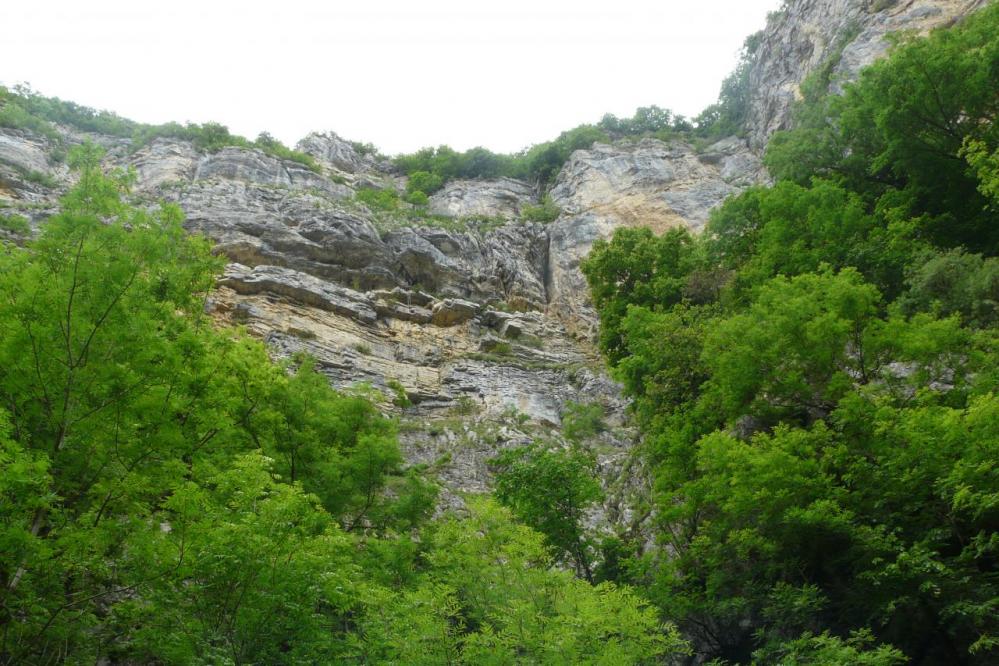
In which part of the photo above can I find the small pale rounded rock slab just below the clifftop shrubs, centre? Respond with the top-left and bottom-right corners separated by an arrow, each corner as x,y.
430,178 -> 535,219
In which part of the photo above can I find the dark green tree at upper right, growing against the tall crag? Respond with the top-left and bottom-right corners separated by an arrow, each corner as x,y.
765,7 -> 999,253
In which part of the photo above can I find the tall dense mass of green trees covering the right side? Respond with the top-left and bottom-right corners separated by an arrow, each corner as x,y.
584,5 -> 999,664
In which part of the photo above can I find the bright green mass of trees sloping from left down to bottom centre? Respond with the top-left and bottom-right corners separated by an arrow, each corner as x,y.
0,145 -> 687,664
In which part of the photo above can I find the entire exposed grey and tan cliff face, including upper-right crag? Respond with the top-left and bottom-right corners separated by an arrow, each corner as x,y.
0,0 -> 985,510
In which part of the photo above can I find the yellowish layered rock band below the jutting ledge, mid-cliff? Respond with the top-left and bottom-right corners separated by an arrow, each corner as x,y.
211,272 -> 624,425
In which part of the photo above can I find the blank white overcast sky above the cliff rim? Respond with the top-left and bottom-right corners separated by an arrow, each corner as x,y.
0,0 -> 780,153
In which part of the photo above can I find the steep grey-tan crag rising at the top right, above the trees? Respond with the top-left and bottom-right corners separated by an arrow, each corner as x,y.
746,0 -> 989,151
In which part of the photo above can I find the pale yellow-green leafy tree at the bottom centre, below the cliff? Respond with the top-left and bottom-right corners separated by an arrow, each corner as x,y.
408,500 -> 688,664
